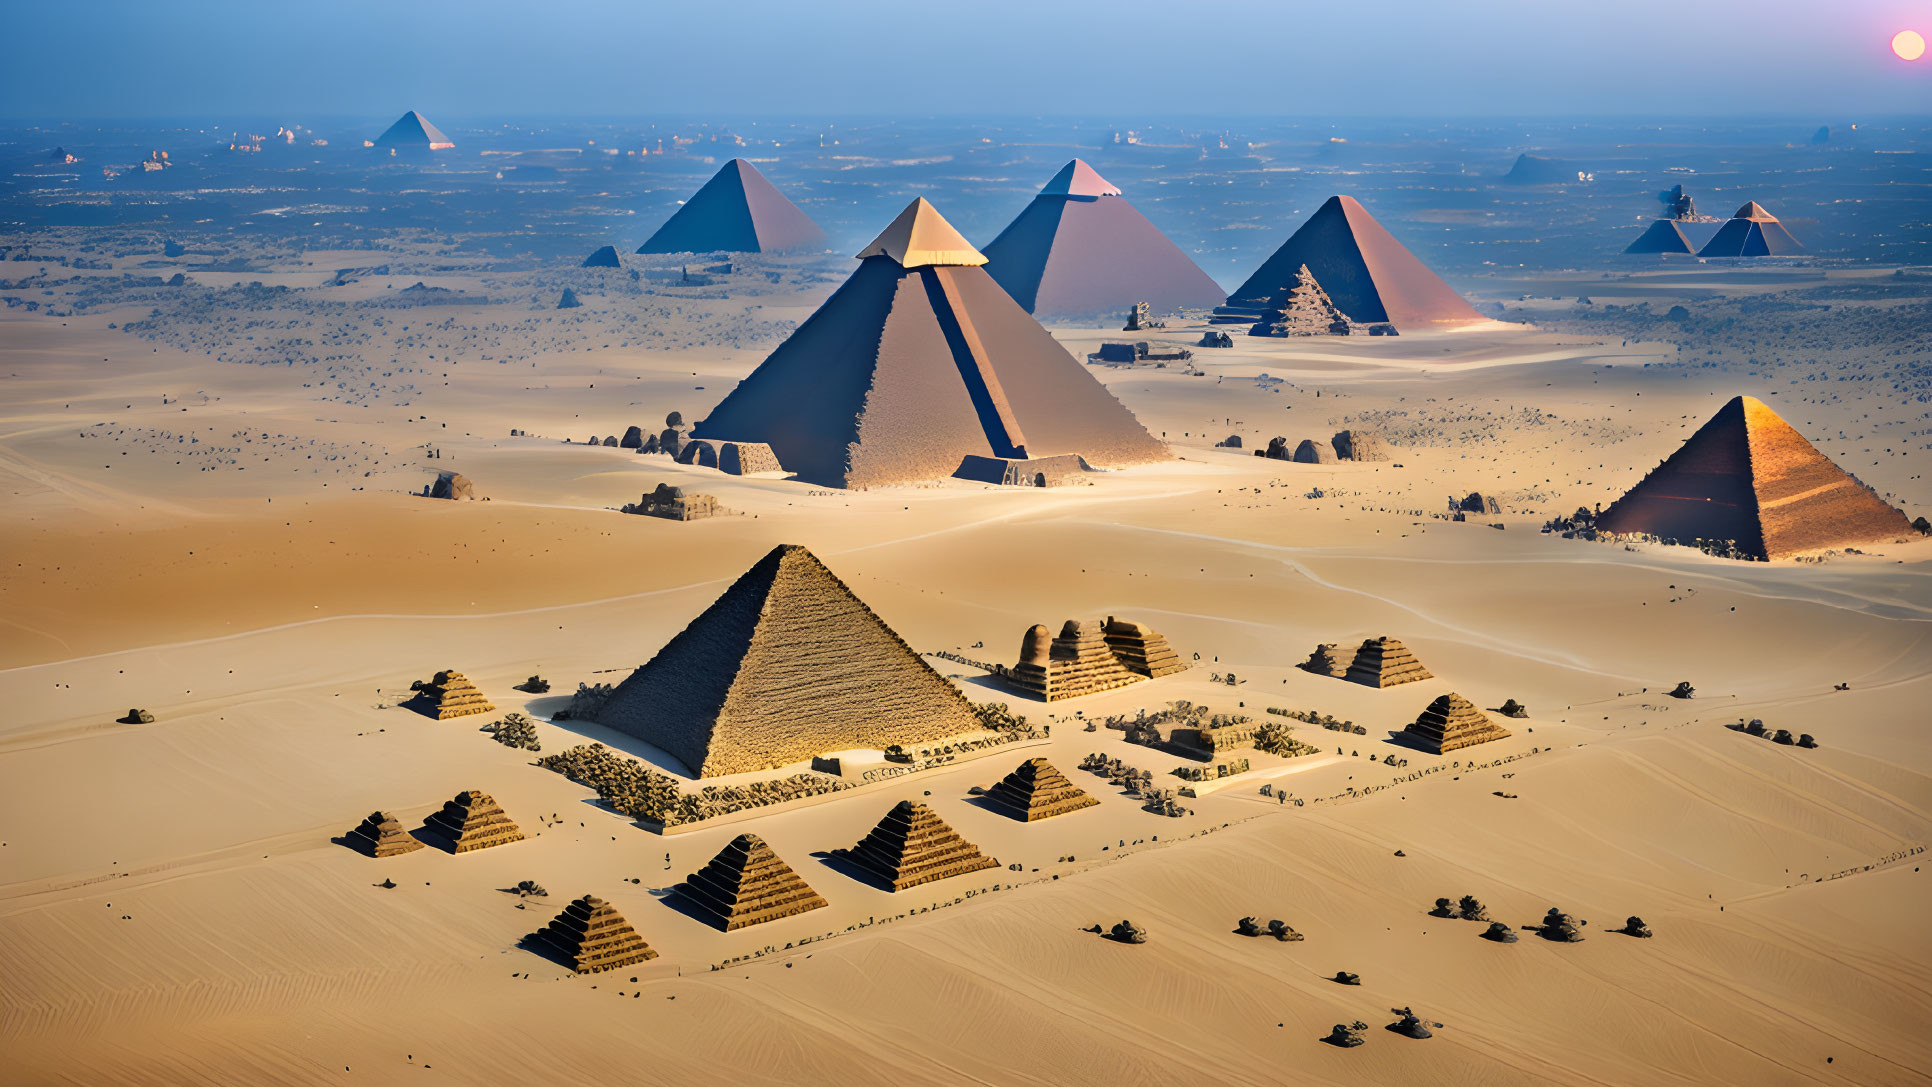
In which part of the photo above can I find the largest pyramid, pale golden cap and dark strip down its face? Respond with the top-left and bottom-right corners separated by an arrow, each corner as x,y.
694,199 -> 1167,487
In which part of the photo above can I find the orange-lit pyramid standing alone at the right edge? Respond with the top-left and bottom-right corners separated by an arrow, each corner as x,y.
1596,395 -> 1911,558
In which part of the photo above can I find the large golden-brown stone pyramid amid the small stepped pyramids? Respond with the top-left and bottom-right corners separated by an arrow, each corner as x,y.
597,544 -> 985,778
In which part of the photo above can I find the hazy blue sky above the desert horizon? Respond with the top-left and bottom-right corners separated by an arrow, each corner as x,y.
0,0 -> 1932,122
